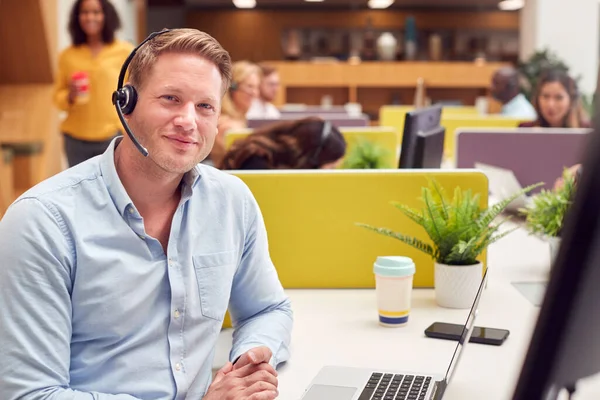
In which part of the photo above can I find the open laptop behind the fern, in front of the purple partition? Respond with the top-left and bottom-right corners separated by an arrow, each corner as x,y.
475,163 -> 533,213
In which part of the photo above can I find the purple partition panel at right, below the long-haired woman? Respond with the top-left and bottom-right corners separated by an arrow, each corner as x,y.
456,128 -> 591,189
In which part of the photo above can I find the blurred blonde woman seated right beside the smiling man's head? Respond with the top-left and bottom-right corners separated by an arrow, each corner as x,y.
209,61 -> 260,165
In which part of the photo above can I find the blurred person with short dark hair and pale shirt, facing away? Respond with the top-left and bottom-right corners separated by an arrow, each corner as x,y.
491,67 -> 537,120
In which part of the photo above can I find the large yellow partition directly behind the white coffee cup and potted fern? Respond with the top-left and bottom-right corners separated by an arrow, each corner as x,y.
231,170 -> 488,288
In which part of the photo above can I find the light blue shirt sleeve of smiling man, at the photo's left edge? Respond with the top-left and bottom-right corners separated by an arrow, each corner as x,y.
0,198 -> 142,400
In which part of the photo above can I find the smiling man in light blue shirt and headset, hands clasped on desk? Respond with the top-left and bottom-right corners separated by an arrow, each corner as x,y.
0,29 -> 292,400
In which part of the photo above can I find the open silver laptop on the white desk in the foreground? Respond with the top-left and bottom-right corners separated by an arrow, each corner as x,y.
301,269 -> 487,400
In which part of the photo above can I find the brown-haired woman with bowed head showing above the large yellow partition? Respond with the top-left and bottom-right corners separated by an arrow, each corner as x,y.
220,117 -> 346,170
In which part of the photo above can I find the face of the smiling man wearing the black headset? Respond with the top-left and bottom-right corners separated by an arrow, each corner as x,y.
129,53 -> 222,174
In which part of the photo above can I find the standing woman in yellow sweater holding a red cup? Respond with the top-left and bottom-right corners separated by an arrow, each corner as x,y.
54,0 -> 133,167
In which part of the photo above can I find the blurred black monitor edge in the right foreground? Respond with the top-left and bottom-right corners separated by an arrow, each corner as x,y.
513,97 -> 600,400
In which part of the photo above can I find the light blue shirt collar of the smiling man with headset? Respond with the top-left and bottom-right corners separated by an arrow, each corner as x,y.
100,137 -> 201,219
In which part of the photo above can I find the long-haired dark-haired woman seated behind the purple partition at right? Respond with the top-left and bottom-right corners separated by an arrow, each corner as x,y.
519,70 -> 590,128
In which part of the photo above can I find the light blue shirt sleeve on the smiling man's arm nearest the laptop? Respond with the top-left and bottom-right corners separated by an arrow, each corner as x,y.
229,189 -> 293,367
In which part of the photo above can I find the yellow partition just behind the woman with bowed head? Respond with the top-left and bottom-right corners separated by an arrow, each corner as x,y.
225,127 -> 400,168
